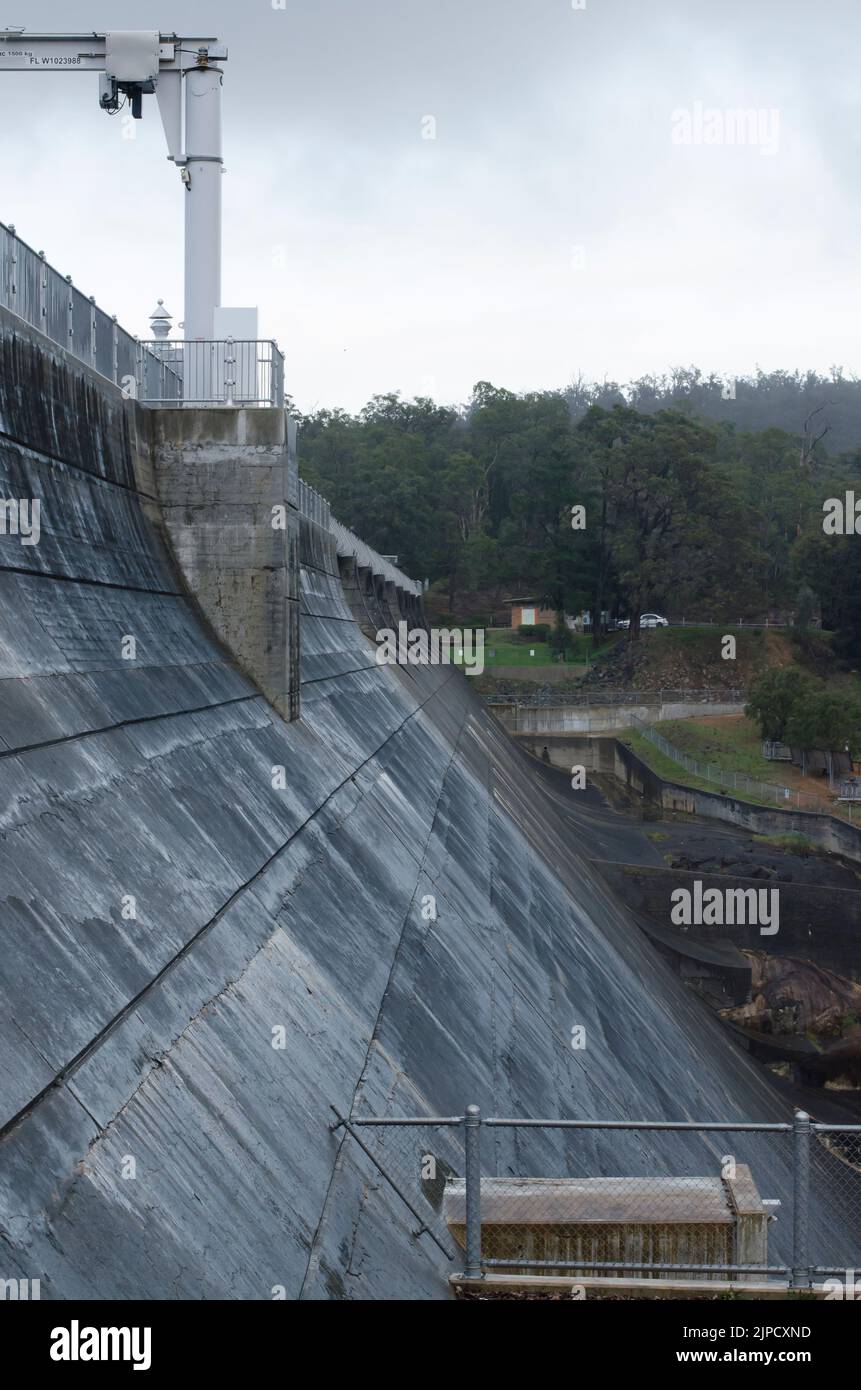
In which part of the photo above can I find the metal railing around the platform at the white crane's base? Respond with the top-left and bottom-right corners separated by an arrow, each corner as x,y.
136,338 -> 284,406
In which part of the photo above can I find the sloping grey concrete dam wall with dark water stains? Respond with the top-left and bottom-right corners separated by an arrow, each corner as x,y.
0,316 -> 855,1300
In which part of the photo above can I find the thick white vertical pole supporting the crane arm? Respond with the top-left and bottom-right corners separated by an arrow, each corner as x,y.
184,67 -> 221,346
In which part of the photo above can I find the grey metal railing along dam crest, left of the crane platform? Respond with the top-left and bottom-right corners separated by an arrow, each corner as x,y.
0,222 -> 181,399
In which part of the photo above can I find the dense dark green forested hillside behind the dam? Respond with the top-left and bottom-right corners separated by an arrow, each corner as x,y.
300,371 -> 861,655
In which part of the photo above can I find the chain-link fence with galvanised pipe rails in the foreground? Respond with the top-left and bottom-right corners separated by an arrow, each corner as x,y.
332,1106 -> 861,1289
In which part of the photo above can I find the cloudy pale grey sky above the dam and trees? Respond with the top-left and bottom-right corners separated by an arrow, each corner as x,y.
0,0 -> 861,410
